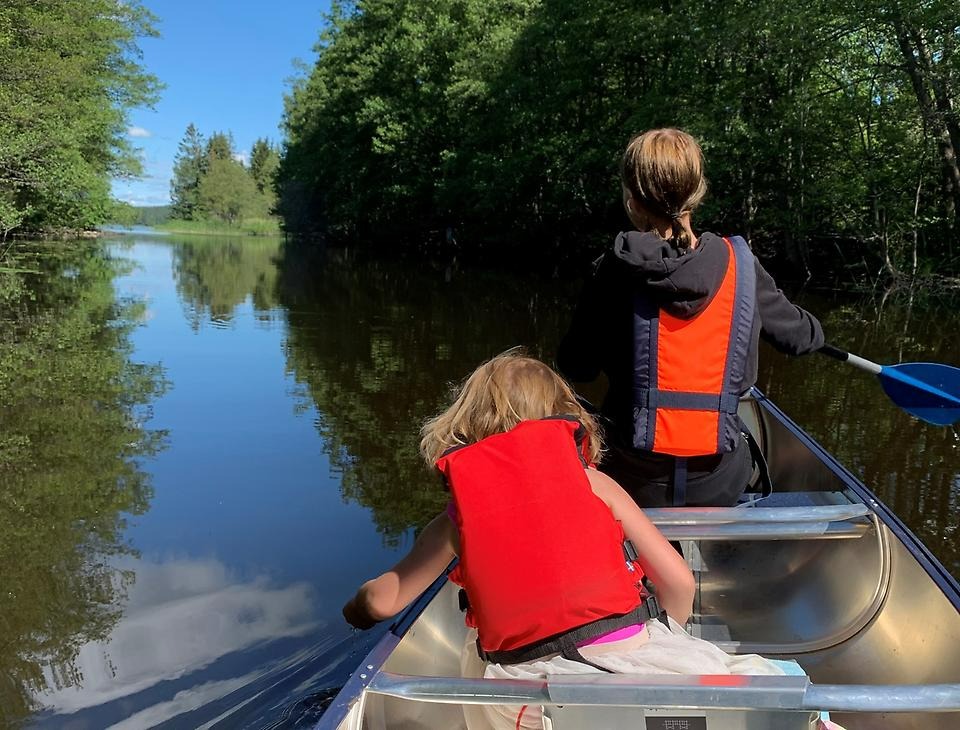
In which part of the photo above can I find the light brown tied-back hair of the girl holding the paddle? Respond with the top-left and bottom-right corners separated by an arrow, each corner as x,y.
620,129 -> 707,249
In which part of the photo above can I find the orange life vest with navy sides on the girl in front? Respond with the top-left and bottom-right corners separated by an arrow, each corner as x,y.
633,236 -> 756,457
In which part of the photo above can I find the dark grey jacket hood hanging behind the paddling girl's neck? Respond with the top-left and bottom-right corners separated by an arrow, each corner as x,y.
609,231 -> 730,319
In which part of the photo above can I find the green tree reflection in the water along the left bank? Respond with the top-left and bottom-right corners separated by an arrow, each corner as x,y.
0,243 -> 164,724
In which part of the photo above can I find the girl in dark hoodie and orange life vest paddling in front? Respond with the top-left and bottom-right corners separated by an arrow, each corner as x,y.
557,129 -> 823,507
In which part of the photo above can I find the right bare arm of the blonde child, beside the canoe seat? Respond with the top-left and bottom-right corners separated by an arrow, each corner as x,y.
587,469 -> 696,624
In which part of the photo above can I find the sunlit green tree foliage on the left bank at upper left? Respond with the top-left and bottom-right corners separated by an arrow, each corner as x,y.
0,0 -> 159,238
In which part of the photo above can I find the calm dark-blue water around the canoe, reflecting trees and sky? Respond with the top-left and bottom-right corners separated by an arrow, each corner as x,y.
0,235 -> 960,730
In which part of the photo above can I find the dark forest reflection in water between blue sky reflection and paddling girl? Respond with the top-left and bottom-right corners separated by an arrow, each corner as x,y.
279,247 -> 568,543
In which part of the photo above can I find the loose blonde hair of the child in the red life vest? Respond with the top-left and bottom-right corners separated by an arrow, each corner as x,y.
420,348 -> 603,467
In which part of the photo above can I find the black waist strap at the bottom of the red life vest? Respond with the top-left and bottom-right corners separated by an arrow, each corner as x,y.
477,594 -> 670,671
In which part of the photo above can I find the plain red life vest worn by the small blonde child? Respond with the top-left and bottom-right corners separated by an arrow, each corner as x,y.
437,418 -> 643,661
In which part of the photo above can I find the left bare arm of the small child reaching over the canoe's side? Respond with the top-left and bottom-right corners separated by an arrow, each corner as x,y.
343,512 -> 457,629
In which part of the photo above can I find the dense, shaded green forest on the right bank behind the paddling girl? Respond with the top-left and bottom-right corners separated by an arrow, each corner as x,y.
278,0 -> 960,282
